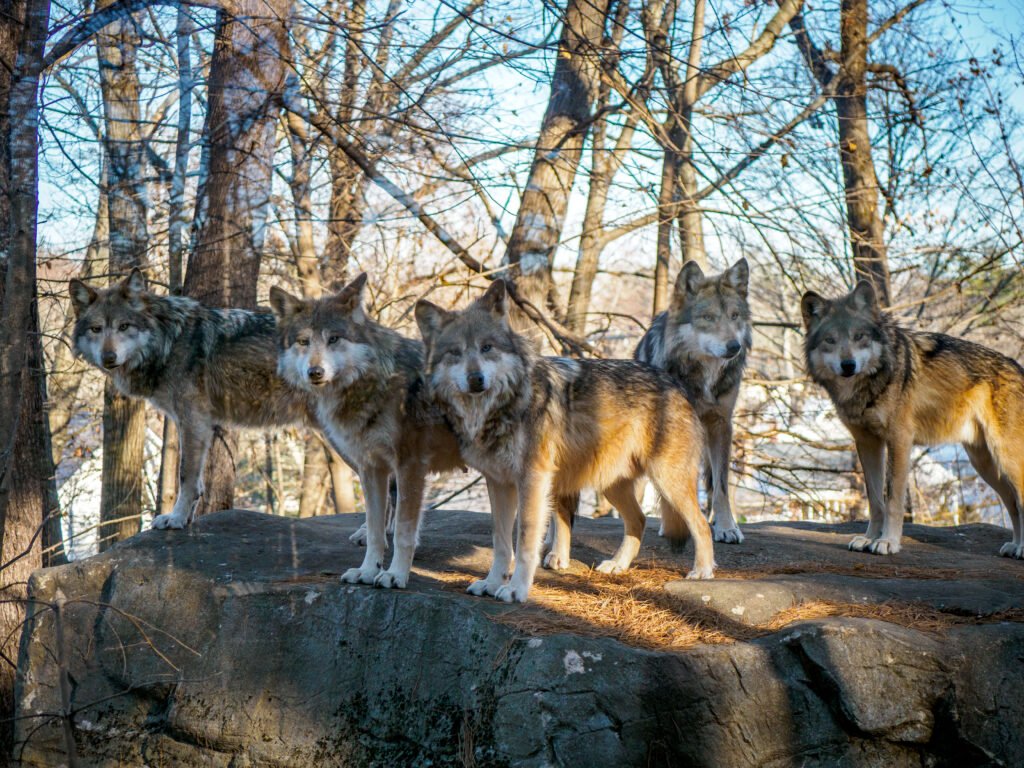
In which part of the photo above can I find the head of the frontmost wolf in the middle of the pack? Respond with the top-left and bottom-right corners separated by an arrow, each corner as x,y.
416,280 -> 525,401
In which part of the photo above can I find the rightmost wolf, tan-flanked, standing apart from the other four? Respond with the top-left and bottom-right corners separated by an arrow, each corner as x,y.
801,281 -> 1024,559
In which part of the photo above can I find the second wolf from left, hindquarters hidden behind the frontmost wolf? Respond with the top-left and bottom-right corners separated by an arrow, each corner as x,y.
270,273 -> 465,589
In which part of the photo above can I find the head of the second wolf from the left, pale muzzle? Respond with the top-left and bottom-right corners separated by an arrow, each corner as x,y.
270,272 -> 377,391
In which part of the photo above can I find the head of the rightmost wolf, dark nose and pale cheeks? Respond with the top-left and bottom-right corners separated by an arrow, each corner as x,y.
800,280 -> 886,382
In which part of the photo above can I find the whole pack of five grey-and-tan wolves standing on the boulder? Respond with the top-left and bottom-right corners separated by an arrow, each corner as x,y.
70,259 -> 1024,602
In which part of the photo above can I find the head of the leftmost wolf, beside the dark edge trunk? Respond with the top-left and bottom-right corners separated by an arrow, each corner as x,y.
68,269 -> 153,371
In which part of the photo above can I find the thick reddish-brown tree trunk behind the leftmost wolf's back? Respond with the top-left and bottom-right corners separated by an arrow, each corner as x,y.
184,0 -> 291,514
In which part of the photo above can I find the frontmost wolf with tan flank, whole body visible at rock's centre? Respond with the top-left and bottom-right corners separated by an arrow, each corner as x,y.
416,280 -> 715,602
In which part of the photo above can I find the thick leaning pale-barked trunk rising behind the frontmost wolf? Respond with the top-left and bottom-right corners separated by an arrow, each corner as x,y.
505,0 -> 610,310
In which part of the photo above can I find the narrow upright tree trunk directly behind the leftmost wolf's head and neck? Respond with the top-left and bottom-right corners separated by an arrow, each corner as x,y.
96,3 -> 148,550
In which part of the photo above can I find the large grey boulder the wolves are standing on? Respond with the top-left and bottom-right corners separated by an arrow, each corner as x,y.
17,510 -> 1024,768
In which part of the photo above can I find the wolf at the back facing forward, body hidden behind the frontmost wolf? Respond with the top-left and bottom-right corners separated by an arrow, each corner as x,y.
633,259 -> 753,544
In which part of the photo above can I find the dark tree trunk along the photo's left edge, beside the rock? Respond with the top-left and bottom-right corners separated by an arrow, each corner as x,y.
0,0 -> 55,755
